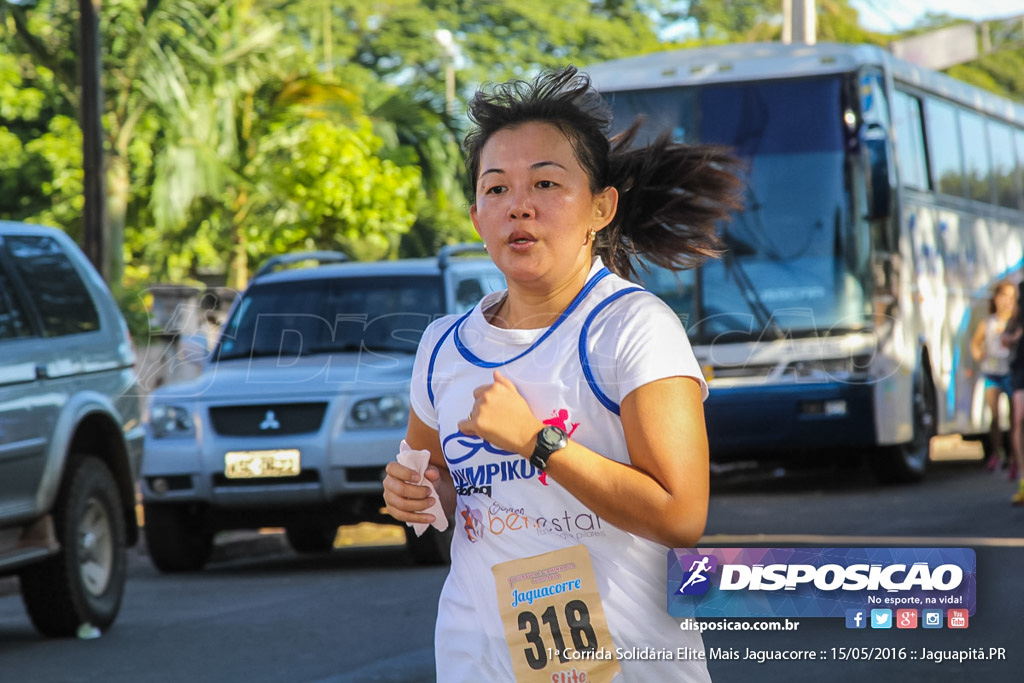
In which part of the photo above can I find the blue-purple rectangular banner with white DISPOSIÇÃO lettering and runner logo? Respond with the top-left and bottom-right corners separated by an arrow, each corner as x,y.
668,548 -> 977,617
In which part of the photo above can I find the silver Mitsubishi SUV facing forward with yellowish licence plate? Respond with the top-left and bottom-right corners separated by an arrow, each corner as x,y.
141,245 -> 505,571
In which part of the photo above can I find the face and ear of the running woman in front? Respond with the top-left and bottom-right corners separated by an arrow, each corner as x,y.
470,123 -> 618,289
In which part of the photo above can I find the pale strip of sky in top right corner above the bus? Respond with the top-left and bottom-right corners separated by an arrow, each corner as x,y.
850,0 -> 1024,33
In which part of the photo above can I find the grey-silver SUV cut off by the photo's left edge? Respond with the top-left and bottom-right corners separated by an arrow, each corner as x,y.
0,222 -> 142,636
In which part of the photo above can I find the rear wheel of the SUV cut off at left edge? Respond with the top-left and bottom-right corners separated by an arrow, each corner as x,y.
20,456 -> 127,637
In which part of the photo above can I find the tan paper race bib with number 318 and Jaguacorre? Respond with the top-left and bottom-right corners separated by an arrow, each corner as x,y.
492,546 -> 620,683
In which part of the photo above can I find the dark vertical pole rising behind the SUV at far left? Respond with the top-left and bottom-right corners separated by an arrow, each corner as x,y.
78,0 -> 110,281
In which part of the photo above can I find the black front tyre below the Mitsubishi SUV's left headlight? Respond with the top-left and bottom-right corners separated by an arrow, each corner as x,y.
142,505 -> 213,573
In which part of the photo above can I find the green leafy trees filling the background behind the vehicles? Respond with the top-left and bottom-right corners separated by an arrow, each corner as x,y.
0,0 -> 1024,317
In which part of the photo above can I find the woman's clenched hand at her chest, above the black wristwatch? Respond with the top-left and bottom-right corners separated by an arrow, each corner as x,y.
459,370 -> 544,458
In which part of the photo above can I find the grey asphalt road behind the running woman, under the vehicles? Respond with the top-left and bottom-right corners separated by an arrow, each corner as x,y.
0,454 -> 1024,683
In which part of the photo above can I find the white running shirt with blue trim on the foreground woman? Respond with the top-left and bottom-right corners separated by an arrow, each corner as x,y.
412,260 -> 710,683
